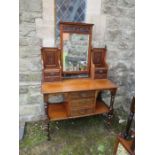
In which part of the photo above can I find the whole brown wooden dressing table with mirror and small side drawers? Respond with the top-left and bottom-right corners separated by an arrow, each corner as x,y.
41,22 -> 117,139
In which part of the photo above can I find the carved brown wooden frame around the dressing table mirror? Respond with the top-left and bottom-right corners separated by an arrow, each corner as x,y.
60,22 -> 94,76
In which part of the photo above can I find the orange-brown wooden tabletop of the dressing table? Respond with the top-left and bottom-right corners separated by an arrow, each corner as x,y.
41,78 -> 117,94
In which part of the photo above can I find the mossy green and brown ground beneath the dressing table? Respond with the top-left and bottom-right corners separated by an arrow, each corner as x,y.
20,110 -> 127,155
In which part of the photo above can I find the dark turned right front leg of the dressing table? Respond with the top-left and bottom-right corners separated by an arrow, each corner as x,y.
108,89 -> 116,121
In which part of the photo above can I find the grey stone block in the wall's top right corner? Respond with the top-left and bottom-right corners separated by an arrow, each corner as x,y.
117,0 -> 135,8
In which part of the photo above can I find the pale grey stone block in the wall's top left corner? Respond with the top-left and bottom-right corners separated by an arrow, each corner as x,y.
19,0 -> 42,12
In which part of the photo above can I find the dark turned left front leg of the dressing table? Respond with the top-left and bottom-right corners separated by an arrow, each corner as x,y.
44,94 -> 50,140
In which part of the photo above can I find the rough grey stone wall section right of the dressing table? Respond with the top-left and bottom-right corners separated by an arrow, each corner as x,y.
101,0 -> 135,111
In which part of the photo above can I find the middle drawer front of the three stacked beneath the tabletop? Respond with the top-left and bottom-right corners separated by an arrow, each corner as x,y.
70,98 -> 95,108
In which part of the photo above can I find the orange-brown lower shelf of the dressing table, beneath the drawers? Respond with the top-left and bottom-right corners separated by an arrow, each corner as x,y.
48,101 -> 109,121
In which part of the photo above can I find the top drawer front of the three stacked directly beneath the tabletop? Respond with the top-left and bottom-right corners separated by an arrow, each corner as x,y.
69,91 -> 95,99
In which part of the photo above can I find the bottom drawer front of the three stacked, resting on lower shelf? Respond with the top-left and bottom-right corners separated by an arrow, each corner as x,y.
71,108 -> 95,116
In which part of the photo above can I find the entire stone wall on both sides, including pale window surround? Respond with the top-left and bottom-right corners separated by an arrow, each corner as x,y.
19,0 -> 134,122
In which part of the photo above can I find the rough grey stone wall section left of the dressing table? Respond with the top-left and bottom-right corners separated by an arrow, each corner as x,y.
19,0 -> 44,122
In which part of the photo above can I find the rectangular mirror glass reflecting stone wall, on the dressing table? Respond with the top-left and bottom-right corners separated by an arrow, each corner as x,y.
62,33 -> 89,73
